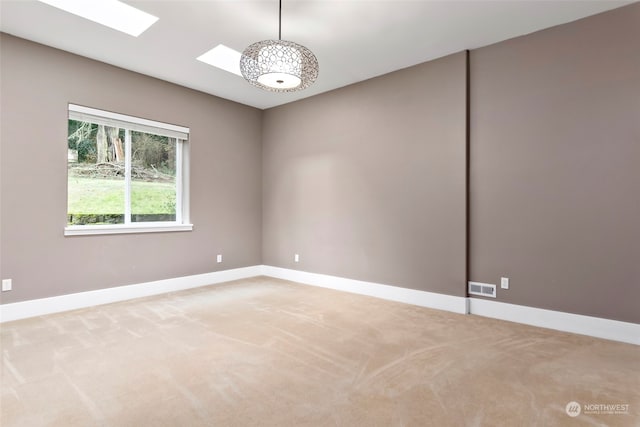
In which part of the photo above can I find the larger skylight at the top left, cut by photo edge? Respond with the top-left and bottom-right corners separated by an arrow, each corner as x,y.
39,0 -> 158,37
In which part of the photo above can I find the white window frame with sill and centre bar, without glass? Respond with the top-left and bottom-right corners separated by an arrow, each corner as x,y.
64,104 -> 193,236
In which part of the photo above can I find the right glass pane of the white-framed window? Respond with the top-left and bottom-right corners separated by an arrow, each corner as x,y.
131,131 -> 177,222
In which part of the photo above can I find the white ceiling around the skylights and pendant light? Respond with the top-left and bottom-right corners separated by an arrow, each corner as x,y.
0,0 -> 633,109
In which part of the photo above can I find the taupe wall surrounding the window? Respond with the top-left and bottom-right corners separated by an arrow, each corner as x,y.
0,34 -> 262,303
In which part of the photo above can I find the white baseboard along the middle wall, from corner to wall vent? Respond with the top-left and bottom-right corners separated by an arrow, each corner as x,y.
262,265 -> 468,314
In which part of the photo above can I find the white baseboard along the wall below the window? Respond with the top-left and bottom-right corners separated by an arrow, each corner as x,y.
0,265 -> 262,322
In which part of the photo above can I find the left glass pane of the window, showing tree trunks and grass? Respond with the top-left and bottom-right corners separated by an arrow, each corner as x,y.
67,120 -> 125,225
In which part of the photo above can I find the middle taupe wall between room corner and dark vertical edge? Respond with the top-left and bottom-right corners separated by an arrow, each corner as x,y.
262,53 -> 466,296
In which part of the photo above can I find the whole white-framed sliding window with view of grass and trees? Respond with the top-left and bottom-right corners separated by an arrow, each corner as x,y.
65,104 -> 193,235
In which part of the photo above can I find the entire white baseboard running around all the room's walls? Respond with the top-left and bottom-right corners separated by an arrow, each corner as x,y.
0,265 -> 640,345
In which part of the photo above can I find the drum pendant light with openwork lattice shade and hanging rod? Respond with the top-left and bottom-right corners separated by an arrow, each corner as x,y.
240,0 -> 318,92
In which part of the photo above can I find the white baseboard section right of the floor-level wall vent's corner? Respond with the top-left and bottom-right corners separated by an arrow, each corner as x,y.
469,298 -> 640,345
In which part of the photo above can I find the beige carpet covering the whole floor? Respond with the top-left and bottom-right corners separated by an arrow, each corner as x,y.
0,277 -> 640,427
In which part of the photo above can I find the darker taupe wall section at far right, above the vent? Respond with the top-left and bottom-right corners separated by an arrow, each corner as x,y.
470,3 -> 640,323
